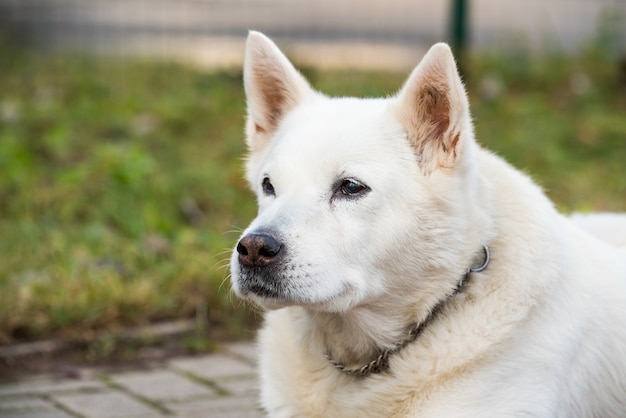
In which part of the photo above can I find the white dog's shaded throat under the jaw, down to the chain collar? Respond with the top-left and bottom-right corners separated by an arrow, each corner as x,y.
302,246 -> 490,377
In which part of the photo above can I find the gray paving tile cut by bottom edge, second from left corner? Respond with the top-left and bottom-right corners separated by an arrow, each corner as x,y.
52,391 -> 159,418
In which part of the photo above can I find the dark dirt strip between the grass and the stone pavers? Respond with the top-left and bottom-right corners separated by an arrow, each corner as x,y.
0,321 -> 253,383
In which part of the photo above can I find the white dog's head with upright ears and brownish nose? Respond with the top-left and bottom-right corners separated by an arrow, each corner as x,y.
231,32 -> 478,312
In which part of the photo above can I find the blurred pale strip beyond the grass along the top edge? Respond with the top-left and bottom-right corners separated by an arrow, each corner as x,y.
0,0 -> 626,69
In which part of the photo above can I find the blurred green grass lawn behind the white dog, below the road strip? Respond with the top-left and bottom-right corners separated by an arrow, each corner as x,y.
0,37 -> 626,343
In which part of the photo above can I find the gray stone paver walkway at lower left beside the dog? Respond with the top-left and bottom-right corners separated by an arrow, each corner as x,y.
0,343 -> 263,418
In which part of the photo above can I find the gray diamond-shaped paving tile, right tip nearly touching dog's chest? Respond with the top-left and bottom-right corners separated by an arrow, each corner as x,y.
169,354 -> 255,381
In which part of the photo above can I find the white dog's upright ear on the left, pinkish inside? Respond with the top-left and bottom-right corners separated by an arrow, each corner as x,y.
243,31 -> 313,151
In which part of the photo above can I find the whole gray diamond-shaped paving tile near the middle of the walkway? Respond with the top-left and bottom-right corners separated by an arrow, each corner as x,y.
110,370 -> 216,400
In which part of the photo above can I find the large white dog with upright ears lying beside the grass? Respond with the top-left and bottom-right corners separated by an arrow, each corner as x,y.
231,33 -> 626,417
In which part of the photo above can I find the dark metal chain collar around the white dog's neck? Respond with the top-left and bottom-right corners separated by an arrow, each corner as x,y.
324,245 -> 490,377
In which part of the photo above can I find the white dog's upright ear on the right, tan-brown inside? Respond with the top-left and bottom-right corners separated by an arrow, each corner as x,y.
398,43 -> 471,175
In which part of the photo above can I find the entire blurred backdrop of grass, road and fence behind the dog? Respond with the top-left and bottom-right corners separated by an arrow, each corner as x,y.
0,0 -> 626,372
